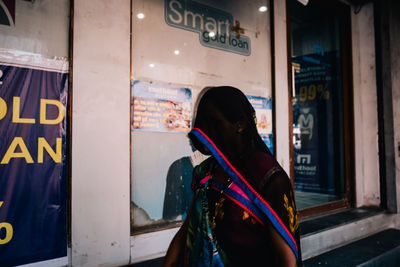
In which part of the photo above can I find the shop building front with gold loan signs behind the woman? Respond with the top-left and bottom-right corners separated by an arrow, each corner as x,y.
0,0 -> 400,266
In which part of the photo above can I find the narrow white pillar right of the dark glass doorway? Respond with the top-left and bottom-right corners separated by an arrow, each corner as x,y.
351,3 -> 380,206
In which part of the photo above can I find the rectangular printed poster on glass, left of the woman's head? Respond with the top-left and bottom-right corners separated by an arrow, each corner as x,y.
131,81 -> 192,132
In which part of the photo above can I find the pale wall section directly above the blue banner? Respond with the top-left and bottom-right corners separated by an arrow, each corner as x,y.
0,0 -> 69,57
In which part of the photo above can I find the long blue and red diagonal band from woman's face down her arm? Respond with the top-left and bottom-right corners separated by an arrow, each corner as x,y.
191,128 -> 298,259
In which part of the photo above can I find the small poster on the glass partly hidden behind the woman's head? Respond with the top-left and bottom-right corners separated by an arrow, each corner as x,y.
247,96 -> 274,153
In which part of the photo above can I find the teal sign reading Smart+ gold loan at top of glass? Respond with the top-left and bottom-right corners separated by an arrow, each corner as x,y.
165,0 -> 251,56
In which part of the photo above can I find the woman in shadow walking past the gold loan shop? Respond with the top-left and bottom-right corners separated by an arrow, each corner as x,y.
164,86 -> 301,266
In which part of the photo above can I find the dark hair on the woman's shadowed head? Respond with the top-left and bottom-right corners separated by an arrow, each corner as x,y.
189,86 -> 270,156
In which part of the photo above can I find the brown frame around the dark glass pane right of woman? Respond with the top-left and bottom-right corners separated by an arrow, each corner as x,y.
286,0 -> 355,218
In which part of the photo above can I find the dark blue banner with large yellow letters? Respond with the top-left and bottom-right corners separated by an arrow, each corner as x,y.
0,57 -> 68,266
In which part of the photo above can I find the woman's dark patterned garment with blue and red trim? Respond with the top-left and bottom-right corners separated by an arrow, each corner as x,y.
181,129 -> 301,266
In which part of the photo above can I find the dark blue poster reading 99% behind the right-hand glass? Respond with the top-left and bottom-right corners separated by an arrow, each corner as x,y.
293,53 -> 340,194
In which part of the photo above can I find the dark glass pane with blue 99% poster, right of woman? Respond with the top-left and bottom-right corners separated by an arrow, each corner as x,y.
290,0 -> 345,209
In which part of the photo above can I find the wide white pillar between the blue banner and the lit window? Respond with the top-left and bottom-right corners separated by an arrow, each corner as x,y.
71,0 -> 130,266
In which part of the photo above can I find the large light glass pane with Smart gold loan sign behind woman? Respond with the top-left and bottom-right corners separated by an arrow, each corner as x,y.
131,0 -> 272,232
